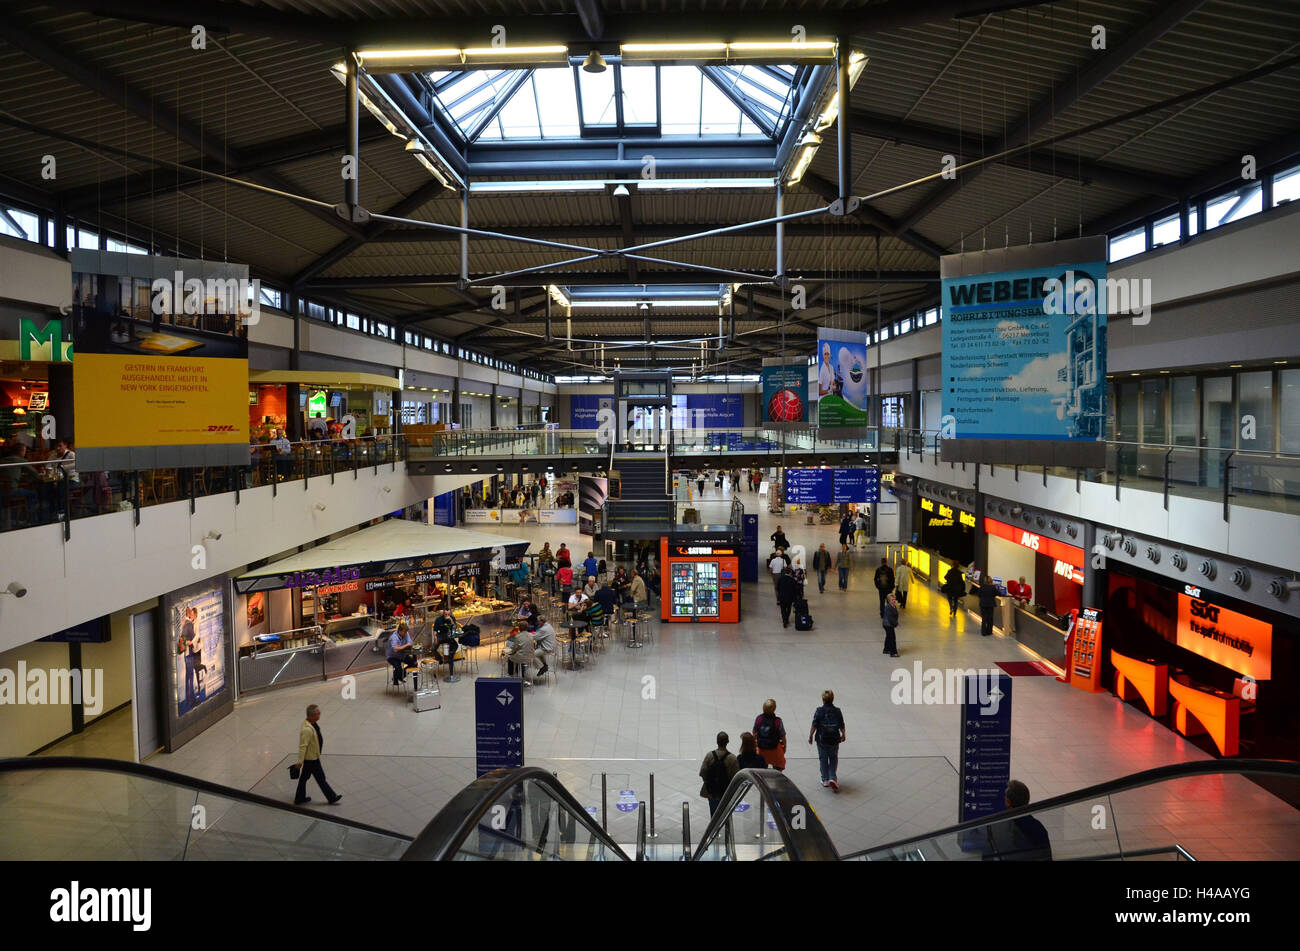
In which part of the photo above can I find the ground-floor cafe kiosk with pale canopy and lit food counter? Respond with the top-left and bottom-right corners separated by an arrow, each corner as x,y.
234,518 -> 529,695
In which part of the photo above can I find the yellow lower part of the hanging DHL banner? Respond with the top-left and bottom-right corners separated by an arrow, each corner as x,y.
73,353 -> 248,448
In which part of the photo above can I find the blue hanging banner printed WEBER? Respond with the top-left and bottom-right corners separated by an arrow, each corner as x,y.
941,238 -> 1106,442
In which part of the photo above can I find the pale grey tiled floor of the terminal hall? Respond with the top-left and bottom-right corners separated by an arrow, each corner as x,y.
38,486 -> 1300,859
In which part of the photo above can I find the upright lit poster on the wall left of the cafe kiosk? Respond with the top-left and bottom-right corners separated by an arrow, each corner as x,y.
166,581 -> 226,717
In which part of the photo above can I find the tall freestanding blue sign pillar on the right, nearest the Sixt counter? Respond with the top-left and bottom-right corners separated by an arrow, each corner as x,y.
958,670 -> 1011,848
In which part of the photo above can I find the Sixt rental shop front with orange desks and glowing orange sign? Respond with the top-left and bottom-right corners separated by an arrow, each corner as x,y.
1101,565 -> 1300,759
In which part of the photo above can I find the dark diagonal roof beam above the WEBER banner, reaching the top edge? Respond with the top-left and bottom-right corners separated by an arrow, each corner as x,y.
898,0 -> 1206,236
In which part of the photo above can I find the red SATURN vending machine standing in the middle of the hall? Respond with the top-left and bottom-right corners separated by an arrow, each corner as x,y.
659,538 -> 740,624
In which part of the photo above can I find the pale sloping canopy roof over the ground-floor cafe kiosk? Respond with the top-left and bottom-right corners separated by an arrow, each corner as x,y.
235,518 -> 529,594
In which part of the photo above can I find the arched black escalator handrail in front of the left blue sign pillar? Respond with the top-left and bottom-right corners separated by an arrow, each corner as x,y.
400,767 -> 632,861
